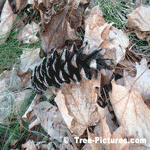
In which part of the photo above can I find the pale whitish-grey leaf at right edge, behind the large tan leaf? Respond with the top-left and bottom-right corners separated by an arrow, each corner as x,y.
124,58 -> 150,100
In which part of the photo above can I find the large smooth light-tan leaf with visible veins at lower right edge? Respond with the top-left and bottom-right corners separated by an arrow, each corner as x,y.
110,80 -> 150,147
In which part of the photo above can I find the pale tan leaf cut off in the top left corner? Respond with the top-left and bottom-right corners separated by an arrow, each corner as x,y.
0,0 -> 17,44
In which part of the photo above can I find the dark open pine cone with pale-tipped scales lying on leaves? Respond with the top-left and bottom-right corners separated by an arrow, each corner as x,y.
31,42 -> 113,92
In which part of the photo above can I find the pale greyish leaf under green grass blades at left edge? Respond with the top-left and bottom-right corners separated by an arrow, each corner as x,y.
0,71 -> 32,124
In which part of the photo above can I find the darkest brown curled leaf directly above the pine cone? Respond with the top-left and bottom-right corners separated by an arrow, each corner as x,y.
41,8 -> 82,52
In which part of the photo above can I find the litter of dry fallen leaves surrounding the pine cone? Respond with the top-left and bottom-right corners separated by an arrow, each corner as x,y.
0,0 -> 150,150
